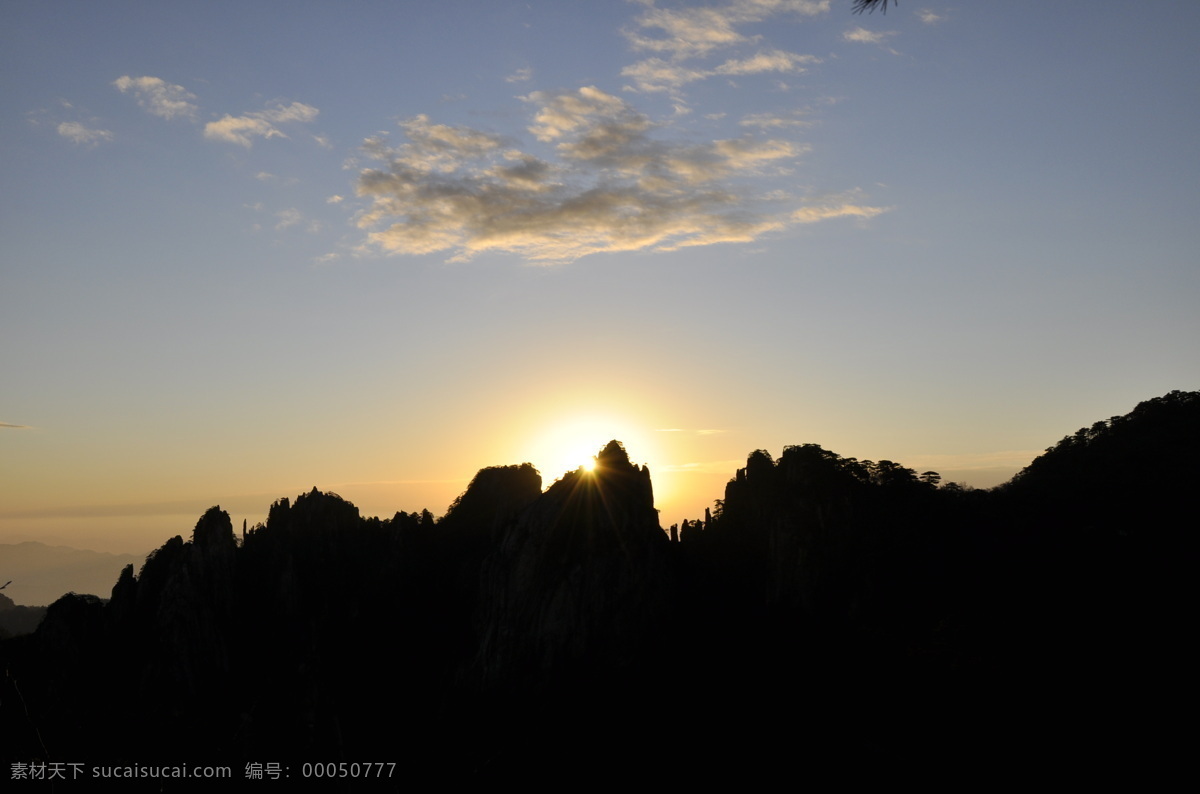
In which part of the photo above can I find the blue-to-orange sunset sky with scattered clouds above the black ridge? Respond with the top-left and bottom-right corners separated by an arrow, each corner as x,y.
0,0 -> 1200,553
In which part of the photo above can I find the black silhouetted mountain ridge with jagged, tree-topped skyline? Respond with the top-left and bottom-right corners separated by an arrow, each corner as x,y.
0,392 -> 1200,780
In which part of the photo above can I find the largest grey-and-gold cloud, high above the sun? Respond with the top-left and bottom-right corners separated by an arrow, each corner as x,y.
358,86 -> 830,264
